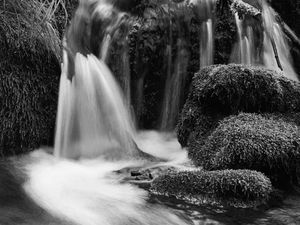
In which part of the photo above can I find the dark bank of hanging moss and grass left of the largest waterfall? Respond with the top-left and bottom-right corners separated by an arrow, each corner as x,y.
0,0 -> 60,156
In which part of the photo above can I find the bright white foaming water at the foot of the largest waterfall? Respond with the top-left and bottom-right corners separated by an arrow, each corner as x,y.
24,131 -> 187,225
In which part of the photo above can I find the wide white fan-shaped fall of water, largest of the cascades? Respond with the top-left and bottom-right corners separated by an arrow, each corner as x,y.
55,53 -> 135,159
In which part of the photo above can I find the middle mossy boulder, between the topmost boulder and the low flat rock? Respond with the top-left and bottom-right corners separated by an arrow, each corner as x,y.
190,113 -> 300,187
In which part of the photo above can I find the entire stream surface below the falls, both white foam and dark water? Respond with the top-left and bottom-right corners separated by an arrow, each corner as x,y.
0,131 -> 300,225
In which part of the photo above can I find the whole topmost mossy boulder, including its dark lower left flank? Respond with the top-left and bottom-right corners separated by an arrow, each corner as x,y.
177,64 -> 300,146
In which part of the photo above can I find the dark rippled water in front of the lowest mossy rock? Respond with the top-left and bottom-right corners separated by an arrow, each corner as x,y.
150,194 -> 300,225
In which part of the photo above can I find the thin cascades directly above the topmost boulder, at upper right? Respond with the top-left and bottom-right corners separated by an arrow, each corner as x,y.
232,1 -> 298,80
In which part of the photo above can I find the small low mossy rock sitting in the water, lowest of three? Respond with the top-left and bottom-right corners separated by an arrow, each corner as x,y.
151,170 -> 272,206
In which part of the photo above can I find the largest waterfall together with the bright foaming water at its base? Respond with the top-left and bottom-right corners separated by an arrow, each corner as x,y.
24,0 -> 192,225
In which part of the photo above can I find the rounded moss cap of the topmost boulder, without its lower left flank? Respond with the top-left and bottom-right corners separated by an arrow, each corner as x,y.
193,64 -> 300,114
